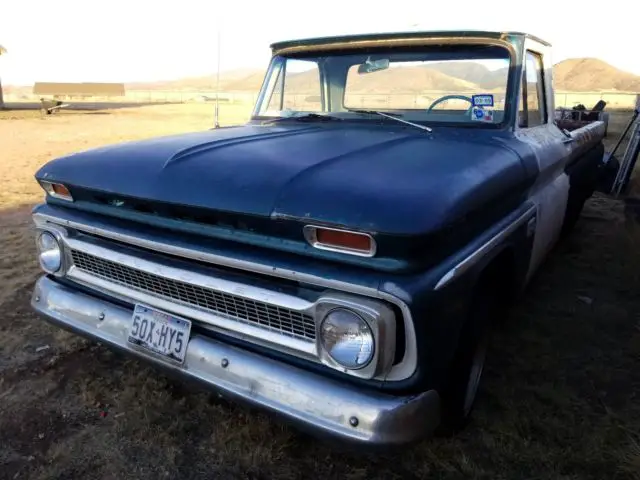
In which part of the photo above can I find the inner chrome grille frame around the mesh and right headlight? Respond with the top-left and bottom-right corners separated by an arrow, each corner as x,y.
47,225 -> 395,379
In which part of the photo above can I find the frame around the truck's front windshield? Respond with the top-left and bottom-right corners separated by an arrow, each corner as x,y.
251,38 -> 519,129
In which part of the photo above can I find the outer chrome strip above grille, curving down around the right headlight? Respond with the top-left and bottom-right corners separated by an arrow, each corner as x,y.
33,212 -> 418,381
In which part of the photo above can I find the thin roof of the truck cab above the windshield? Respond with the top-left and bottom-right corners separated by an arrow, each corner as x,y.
271,30 -> 551,52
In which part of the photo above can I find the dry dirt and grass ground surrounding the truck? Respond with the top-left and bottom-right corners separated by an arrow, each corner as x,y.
0,105 -> 640,480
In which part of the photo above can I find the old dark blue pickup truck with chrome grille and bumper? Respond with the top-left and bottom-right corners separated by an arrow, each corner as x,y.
31,31 -> 604,447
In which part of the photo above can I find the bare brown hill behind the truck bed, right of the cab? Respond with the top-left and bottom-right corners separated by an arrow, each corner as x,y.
553,58 -> 640,92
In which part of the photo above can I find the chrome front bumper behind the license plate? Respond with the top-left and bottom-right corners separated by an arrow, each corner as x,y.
31,277 -> 440,446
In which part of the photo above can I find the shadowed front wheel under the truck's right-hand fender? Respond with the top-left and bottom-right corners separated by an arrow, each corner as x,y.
436,279 -> 499,436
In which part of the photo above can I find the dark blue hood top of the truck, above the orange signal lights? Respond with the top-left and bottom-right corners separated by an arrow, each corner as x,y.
36,123 -> 525,235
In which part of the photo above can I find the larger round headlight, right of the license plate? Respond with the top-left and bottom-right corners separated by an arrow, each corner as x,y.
320,308 -> 375,370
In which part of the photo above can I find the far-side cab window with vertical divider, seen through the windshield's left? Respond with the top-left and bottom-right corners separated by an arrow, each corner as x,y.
267,58 -> 322,112
